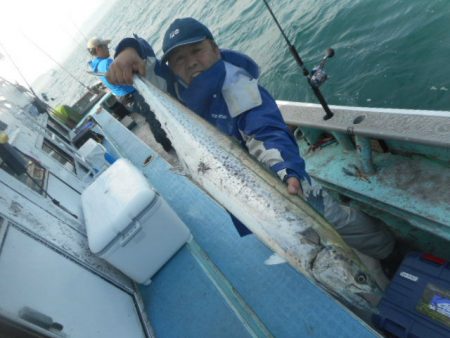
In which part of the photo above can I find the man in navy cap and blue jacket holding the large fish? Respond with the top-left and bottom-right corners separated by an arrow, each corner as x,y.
108,18 -> 395,274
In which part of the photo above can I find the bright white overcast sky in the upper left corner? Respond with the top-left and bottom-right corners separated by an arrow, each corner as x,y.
0,0 -> 110,85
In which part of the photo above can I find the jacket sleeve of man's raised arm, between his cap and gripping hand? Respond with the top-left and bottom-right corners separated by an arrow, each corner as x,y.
114,34 -> 173,91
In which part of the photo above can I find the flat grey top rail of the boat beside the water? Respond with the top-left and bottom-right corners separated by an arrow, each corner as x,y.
277,101 -> 450,147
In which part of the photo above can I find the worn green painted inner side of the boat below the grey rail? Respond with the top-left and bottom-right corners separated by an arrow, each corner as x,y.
297,133 -> 450,259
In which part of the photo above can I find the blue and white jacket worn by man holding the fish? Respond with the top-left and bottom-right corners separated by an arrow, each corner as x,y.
116,36 -> 309,235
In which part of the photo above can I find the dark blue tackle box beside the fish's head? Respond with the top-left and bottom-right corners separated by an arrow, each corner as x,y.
373,252 -> 450,338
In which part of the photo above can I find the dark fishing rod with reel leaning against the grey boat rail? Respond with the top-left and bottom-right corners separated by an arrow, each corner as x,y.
263,0 -> 334,120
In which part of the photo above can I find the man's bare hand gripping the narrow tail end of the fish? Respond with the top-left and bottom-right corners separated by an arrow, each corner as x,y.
106,48 -> 145,85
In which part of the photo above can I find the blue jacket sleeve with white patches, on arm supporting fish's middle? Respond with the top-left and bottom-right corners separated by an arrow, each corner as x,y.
237,87 -> 309,181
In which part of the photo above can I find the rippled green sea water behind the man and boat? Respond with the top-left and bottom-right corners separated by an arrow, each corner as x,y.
37,0 -> 450,110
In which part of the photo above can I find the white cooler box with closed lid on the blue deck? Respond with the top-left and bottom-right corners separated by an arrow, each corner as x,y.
81,159 -> 191,284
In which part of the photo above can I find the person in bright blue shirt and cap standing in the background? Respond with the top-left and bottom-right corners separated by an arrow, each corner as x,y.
87,37 -> 172,152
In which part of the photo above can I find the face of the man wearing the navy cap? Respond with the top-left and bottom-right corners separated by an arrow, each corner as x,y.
168,39 -> 220,85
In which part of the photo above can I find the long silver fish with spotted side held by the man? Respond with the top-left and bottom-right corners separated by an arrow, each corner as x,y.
134,76 -> 381,311
